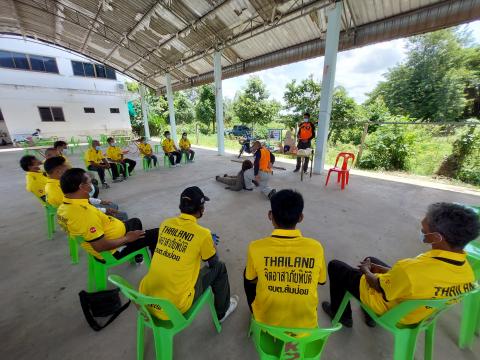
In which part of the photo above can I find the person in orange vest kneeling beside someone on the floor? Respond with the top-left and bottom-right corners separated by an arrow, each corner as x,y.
243,141 -> 277,199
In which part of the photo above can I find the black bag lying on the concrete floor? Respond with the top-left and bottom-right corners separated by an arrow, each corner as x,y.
78,288 -> 130,331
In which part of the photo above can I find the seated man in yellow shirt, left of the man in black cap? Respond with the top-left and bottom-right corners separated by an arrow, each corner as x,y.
57,168 -> 158,263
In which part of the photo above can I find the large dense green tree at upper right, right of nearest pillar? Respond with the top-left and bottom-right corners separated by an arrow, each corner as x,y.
370,29 -> 476,122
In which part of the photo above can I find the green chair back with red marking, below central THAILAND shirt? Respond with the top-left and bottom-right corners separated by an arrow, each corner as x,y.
248,316 -> 342,360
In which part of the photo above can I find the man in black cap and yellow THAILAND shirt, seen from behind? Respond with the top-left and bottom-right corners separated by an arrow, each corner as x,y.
140,186 -> 238,321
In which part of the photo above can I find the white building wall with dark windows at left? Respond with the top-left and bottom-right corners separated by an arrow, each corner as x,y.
0,38 -> 131,140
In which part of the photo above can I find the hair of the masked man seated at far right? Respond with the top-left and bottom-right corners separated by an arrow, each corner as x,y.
425,202 -> 480,250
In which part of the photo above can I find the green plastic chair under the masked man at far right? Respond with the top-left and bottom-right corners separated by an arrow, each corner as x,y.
332,288 -> 480,360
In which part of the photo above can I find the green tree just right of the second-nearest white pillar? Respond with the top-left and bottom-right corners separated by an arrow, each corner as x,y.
233,76 -> 280,125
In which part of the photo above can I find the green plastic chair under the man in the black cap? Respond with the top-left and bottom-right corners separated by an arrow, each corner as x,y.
108,275 -> 222,360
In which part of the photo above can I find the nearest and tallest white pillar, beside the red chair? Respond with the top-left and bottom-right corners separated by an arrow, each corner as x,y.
313,1 -> 343,174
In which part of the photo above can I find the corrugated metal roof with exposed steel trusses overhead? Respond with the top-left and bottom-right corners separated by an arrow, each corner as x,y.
0,0 -> 480,91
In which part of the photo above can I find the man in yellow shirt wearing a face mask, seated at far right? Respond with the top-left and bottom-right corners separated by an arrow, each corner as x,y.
322,203 -> 480,327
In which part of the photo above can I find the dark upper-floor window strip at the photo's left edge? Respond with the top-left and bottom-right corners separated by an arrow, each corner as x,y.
0,50 -> 58,74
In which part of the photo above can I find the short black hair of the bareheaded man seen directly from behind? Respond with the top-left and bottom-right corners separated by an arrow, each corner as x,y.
270,189 -> 303,229
